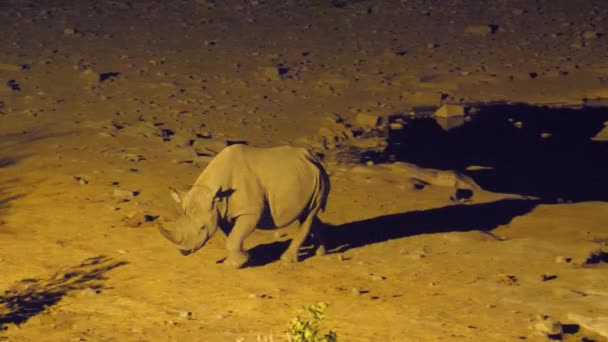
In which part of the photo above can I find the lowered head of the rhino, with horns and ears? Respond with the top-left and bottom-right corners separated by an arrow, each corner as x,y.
158,186 -> 223,255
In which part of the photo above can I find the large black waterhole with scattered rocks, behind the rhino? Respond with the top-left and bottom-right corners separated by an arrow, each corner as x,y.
375,104 -> 608,203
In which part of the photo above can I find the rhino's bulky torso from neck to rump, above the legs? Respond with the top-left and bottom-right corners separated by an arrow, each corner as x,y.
188,145 -> 329,227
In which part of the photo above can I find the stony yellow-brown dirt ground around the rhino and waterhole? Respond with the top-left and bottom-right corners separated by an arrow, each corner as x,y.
0,0 -> 608,341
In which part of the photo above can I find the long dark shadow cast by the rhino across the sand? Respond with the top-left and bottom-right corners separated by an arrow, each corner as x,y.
247,199 -> 539,267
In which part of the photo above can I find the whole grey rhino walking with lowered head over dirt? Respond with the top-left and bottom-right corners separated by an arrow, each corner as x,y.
158,144 -> 330,268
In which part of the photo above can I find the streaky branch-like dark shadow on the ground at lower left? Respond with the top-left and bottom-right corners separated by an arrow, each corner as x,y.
0,256 -> 127,331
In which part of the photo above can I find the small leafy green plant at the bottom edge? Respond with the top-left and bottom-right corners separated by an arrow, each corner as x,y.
288,302 -> 338,342
